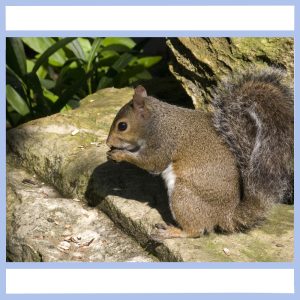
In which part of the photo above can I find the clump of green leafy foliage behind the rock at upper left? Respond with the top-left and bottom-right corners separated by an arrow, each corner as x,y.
6,37 -> 161,126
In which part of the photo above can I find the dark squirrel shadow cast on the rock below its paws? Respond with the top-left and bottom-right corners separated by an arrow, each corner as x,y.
85,161 -> 174,223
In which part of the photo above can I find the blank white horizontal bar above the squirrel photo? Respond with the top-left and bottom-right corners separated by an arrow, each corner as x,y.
6,5 -> 294,31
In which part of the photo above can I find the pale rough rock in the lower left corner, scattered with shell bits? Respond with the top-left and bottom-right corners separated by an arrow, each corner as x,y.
7,164 -> 156,262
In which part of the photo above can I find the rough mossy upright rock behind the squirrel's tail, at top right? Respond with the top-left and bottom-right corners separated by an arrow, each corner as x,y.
167,38 -> 294,109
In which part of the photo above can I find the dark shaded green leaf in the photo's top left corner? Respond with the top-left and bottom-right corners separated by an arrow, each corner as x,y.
6,38 -> 27,77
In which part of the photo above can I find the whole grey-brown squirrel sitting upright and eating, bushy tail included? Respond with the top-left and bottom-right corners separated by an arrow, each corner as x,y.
106,67 -> 294,241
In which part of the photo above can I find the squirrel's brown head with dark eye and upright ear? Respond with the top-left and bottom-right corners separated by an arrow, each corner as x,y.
106,85 -> 149,152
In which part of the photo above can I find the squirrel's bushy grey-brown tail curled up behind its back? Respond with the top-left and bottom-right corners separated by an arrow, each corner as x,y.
213,68 -> 294,228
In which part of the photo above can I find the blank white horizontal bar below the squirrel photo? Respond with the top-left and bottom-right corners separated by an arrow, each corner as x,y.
6,269 -> 294,294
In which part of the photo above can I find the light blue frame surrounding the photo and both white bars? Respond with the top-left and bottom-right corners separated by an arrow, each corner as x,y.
0,0 -> 300,300
